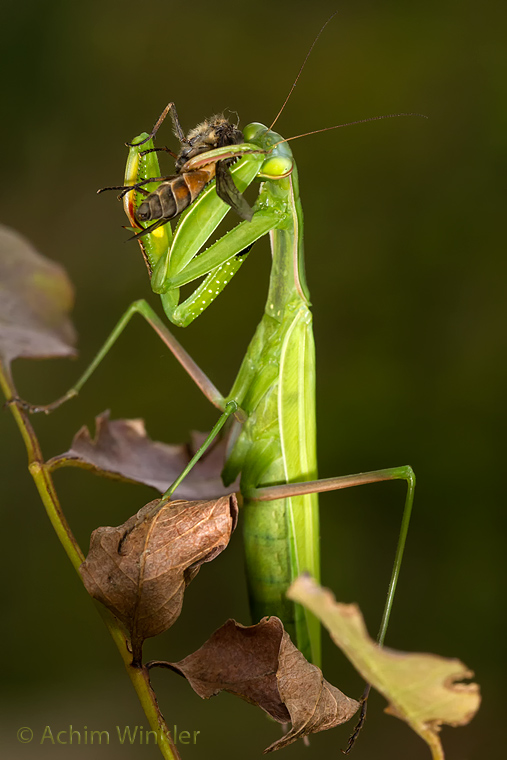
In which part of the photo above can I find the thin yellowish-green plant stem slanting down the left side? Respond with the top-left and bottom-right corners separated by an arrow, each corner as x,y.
0,362 -> 180,760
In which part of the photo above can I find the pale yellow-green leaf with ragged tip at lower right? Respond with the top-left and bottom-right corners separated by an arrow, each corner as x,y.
287,576 -> 481,760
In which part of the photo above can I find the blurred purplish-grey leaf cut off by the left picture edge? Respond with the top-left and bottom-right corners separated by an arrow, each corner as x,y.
0,225 -> 76,365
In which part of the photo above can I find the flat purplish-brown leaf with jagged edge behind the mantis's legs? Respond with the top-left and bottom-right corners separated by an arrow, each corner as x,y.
48,412 -> 239,499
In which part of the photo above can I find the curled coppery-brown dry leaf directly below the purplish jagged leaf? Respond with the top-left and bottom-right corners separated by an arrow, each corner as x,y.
80,494 -> 238,662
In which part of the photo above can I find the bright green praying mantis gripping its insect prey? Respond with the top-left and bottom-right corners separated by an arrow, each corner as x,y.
23,27 -> 415,676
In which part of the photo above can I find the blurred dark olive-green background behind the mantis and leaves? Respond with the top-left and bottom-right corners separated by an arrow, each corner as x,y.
0,0 -> 507,760
